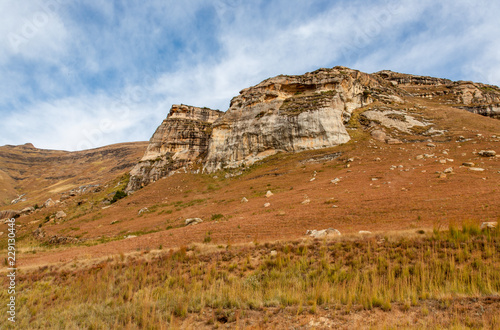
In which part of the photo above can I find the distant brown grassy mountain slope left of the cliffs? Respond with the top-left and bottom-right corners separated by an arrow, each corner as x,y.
0,142 -> 147,209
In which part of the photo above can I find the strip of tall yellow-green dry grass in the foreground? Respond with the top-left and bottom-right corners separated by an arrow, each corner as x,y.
0,224 -> 500,329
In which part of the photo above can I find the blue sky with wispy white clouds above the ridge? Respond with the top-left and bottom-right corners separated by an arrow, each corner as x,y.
0,0 -> 500,151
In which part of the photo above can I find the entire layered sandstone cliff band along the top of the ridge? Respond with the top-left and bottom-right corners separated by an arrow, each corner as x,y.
127,67 -> 500,191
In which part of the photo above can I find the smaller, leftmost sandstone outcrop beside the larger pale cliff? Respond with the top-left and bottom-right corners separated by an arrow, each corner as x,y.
126,105 -> 223,192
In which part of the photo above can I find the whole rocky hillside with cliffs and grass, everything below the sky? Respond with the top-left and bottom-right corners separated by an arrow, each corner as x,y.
0,67 -> 500,329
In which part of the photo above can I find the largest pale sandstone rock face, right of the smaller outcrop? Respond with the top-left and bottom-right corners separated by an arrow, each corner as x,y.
204,67 -> 397,172
